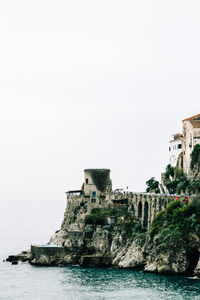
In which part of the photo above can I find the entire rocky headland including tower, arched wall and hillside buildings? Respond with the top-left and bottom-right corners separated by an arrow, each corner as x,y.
7,115 -> 200,277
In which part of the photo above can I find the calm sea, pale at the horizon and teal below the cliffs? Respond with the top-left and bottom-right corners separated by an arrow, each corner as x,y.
0,200 -> 200,300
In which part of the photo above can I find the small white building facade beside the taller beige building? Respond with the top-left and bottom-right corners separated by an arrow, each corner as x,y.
169,133 -> 182,167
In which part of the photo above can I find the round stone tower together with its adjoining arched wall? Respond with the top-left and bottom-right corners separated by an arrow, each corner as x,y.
65,169 -> 180,229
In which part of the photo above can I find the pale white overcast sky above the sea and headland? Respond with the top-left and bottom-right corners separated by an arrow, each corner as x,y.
0,0 -> 200,201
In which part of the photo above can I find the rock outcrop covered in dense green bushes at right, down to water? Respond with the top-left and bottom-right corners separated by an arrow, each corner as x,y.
145,198 -> 200,276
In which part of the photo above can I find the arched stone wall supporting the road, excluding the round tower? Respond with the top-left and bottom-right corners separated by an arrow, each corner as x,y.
64,191 -> 188,230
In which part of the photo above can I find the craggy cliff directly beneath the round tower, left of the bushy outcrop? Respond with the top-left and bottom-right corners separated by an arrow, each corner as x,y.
47,199 -> 146,269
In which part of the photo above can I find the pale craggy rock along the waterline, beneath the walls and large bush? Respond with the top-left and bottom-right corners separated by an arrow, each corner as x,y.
7,193 -> 200,276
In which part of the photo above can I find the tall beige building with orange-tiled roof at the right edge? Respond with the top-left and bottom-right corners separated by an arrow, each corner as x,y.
182,114 -> 200,174
